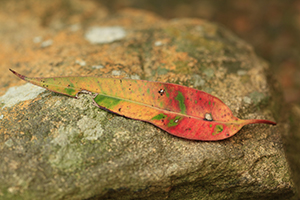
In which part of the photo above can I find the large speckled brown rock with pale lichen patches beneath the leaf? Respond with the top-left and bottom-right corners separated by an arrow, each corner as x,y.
0,0 -> 294,200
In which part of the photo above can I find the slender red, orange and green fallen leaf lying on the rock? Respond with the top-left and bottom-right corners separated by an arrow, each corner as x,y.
10,70 -> 276,141
